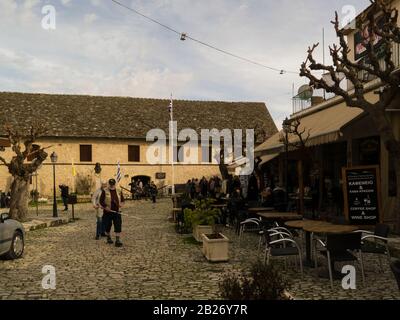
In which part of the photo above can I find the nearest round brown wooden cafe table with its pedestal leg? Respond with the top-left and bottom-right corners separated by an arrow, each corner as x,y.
286,220 -> 359,267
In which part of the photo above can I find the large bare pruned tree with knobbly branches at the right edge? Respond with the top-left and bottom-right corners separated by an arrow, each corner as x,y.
300,0 -> 400,231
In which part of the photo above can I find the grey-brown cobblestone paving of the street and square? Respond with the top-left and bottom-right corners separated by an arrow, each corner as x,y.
0,199 -> 400,300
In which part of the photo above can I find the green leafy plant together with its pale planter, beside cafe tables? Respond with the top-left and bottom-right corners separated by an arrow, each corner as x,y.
184,199 -> 221,242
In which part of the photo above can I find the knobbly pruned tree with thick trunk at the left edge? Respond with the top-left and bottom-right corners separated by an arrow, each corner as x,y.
0,125 -> 48,221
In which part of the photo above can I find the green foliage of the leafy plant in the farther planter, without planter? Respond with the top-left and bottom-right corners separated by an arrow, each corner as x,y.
184,199 -> 221,229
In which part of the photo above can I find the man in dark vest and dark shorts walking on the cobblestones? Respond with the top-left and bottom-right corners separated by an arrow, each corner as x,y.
100,179 -> 124,247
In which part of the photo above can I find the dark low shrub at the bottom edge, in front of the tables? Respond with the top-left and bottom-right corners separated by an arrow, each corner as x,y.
219,261 -> 289,301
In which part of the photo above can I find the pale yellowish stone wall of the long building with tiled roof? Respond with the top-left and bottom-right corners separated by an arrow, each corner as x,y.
0,139 -> 219,197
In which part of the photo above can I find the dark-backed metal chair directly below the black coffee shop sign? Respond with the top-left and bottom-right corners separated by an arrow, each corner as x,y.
354,224 -> 391,270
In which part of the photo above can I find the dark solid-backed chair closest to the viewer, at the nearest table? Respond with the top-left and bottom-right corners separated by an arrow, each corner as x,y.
315,233 -> 365,289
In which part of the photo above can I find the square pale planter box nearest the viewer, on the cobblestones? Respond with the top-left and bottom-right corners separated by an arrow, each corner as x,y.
203,233 -> 229,262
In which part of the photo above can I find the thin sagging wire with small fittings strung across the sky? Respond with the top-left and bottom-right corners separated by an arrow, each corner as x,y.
111,0 -> 300,75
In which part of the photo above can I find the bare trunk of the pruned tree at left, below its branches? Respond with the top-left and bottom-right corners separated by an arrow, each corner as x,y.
10,176 -> 29,221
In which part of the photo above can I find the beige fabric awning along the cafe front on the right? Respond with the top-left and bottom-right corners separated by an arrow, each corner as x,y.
255,103 -> 363,156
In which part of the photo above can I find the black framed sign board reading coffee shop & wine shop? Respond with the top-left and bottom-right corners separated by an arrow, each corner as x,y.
343,166 -> 381,225
